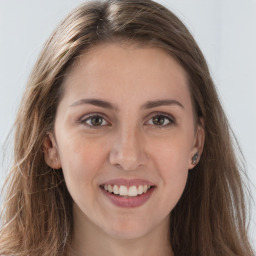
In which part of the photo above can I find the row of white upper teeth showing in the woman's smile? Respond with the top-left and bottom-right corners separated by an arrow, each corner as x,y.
103,184 -> 151,197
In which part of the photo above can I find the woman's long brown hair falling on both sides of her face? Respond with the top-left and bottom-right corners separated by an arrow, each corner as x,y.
0,0 -> 253,256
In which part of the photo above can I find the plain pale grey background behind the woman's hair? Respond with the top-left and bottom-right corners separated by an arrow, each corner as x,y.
0,0 -> 256,248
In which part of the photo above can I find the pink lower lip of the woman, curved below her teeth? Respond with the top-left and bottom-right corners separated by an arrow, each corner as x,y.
100,187 -> 155,208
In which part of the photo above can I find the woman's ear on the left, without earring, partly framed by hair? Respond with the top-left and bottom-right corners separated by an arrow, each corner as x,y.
43,132 -> 61,169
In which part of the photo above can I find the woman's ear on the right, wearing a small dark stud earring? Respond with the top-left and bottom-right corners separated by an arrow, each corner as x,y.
188,118 -> 205,169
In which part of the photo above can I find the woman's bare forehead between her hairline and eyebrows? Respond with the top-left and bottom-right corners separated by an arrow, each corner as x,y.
60,43 -> 190,109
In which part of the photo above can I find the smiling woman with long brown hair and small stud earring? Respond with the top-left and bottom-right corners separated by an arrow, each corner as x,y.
0,0 -> 253,256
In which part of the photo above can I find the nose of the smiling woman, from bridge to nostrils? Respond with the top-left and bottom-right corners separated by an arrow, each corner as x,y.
109,125 -> 148,171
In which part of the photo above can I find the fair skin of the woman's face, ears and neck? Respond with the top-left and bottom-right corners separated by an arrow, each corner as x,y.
45,43 -> 204,256
